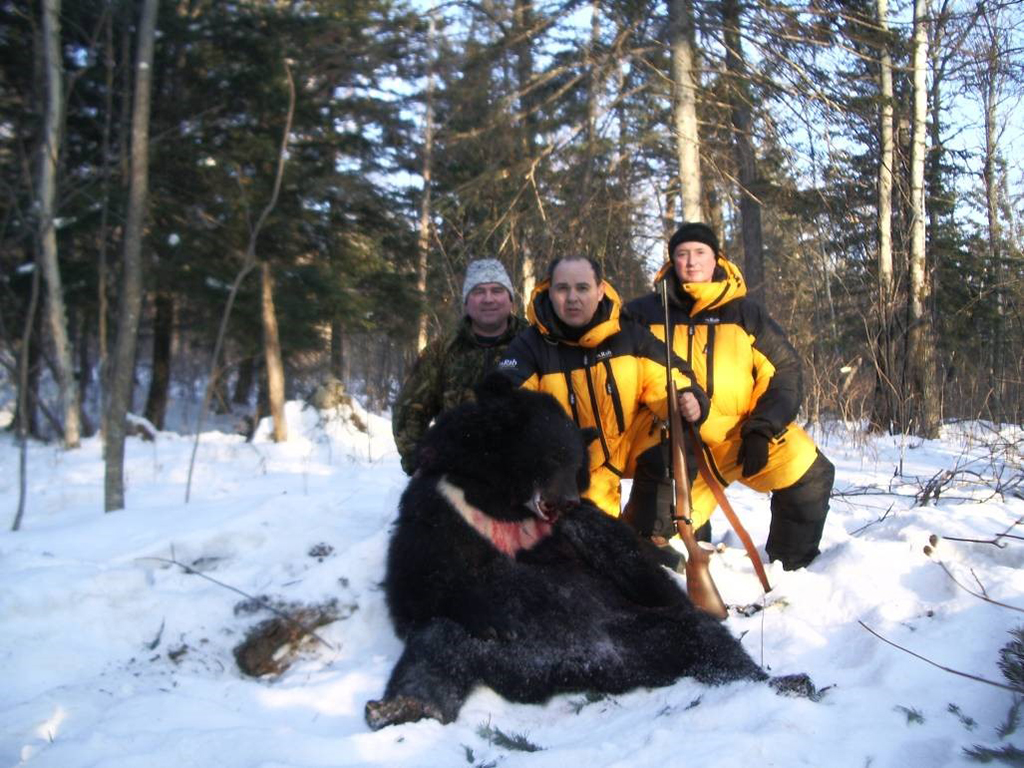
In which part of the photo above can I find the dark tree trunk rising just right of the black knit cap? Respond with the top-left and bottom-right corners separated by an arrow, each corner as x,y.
722,0 -> 765,302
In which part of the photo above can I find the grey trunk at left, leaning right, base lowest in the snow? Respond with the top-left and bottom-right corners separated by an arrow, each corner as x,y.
103,0 -> 158,512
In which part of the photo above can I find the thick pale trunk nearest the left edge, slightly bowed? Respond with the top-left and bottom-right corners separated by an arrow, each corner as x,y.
38,0 -> 82,449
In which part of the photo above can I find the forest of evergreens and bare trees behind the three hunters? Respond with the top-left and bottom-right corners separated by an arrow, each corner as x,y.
0,0 -> 1024,518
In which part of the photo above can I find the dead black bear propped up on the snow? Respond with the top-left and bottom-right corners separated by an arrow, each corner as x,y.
366,375 -> 809,729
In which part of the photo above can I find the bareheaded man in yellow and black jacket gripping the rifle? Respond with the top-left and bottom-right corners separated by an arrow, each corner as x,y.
498,257 -> 708,516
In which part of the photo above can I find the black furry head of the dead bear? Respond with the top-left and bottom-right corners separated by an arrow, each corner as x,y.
418,373 -> 596,521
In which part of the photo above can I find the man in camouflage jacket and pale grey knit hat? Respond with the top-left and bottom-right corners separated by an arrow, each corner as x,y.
391,259 -> 526,475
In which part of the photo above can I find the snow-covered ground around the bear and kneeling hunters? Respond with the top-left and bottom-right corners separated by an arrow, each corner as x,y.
0,403 -> 1024,768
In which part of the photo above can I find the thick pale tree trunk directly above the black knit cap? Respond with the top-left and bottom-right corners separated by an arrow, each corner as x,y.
669,0 -> 702,221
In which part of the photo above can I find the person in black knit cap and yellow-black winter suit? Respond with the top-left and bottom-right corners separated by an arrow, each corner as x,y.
627,223 -> 836,570
